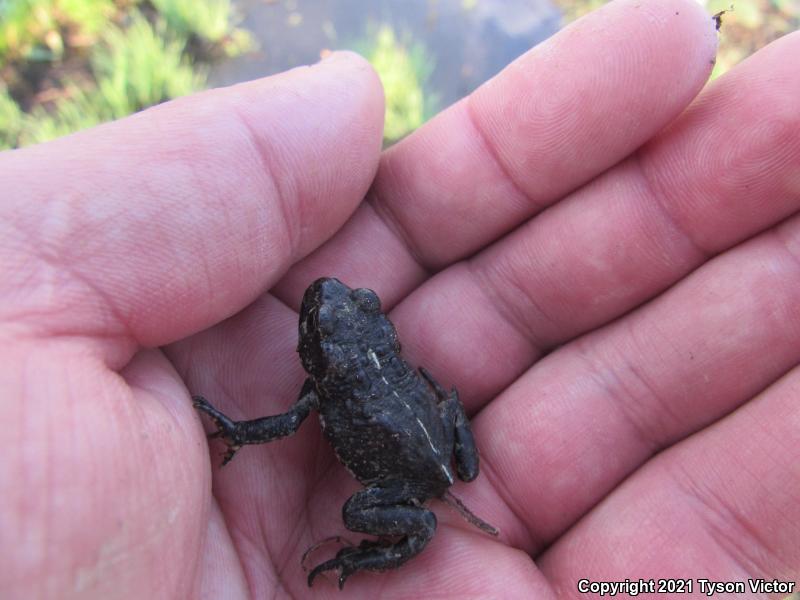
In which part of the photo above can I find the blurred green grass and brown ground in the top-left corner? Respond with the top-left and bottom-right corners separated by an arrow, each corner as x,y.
0,0 -> 253,149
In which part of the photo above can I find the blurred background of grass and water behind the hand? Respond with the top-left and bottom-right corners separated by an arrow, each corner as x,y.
0,0 -> 800,149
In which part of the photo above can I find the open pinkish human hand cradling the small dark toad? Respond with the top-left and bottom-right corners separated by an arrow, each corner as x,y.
0,0 -> 800,599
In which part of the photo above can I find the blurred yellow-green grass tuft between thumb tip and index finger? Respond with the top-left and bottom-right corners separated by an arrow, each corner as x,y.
355,25 -> 438,145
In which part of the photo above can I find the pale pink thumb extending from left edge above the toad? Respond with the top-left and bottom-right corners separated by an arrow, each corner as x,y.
0,53 -> 383,349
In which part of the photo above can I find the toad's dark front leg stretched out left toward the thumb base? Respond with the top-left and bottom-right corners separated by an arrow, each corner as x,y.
192,379 -> 319,466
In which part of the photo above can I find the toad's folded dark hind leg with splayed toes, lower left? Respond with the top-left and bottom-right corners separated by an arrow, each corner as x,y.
308,486 -> 436,589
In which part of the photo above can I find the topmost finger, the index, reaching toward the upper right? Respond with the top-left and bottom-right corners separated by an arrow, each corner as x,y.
277,0 -> 717,306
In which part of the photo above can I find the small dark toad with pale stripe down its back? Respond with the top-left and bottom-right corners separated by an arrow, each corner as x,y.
193,278 -> 497,588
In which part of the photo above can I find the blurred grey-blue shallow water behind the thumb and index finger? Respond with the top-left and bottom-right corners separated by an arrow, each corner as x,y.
211,0 -> 561,107
